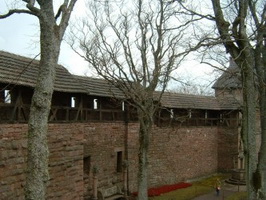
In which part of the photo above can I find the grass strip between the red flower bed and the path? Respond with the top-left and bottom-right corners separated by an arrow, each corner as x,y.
149,175 -> 227,200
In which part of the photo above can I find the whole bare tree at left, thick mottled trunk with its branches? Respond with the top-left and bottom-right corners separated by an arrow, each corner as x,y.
0,0 -> 77,200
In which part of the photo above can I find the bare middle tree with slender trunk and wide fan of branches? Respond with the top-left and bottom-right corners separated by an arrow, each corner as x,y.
69,0 -> 192,200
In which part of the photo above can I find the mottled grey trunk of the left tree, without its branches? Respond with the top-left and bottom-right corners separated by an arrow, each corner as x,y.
25,10 -> 60,200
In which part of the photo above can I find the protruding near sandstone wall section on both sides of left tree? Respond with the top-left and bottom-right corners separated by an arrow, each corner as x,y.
0,124 -> 83,200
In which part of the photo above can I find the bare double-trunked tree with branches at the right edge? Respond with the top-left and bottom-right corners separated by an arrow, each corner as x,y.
178,0 -> 266,200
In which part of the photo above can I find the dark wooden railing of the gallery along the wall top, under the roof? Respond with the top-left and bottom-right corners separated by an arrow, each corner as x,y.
0,103 -> 240,127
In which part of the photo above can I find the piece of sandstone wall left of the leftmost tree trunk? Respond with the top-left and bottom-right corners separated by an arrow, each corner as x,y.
0,124 -> 27,200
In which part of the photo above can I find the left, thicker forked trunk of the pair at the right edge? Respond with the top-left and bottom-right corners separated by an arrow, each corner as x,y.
212,0 -> 264,200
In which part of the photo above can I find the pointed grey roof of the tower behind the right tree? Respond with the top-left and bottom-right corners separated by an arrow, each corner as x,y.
212,59 -> 242,89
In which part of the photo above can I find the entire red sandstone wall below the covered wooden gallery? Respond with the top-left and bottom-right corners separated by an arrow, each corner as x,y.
0,122 -> 236,200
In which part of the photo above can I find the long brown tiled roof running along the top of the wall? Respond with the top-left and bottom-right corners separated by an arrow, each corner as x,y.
0,51 -> 239,110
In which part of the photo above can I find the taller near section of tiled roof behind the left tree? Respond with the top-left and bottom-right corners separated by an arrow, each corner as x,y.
0,51 -> 86,93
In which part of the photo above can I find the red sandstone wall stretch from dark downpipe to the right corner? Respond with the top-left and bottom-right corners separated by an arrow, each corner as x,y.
125,125 -> 218,191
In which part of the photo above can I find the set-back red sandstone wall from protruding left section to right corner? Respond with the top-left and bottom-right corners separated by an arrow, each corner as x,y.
84,123 -> 218,192
